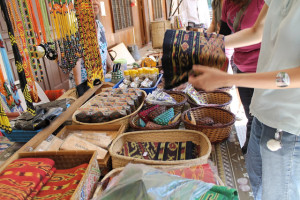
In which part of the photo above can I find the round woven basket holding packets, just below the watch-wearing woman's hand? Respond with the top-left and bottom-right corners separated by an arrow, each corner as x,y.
188,91 -> 232,110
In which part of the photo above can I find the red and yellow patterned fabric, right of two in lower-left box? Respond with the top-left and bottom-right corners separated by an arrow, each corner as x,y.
34,163 -> 88,200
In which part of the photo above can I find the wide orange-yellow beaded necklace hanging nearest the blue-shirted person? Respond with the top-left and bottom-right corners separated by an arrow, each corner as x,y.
75,0 -> 104,87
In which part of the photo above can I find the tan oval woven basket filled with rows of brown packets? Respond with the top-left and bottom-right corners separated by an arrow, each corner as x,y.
72,90 -> 147,126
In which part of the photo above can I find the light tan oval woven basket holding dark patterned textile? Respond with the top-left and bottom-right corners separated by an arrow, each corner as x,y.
109,130 -> 211,168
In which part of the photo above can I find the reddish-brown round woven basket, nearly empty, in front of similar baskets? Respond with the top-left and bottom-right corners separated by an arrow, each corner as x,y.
181,107 -> 235,143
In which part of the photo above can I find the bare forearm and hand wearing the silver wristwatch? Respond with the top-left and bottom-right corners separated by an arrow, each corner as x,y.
189,65 -> 300,91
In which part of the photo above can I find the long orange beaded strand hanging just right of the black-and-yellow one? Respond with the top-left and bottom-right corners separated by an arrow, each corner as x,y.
7,1 -> 38,102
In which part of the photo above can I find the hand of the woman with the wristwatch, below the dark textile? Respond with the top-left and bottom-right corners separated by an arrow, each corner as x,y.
189,65 -> 231,91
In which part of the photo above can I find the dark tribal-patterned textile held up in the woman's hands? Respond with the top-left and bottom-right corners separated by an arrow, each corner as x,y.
162,30 -> 228,89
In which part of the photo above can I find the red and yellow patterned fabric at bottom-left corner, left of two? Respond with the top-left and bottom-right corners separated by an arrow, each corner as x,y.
0,158 -> 54,200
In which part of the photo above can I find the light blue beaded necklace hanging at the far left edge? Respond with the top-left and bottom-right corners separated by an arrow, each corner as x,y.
0,34 -> 23,112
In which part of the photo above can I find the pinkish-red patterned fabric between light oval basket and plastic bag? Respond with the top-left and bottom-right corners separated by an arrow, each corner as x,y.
168,164 -> 216,184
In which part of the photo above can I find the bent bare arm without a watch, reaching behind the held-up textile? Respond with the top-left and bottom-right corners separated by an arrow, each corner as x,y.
225,4 -> 268,48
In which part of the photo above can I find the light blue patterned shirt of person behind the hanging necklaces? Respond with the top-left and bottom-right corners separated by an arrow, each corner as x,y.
69,20 -> 107,88
